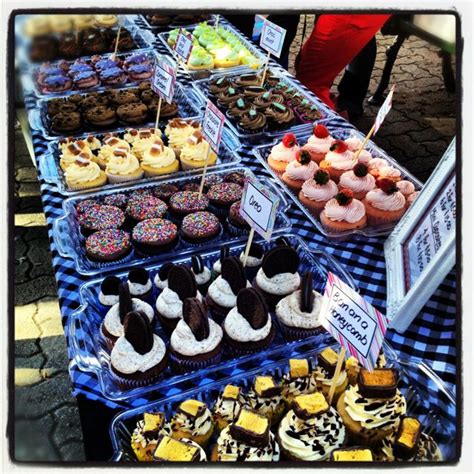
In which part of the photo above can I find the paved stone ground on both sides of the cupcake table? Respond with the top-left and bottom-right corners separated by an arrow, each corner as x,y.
10,16 -> 455,461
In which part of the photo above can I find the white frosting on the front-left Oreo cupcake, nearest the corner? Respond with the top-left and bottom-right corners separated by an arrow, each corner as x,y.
110,334 -> 166,374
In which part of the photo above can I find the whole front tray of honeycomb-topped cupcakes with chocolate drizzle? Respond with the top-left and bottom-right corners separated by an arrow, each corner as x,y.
110,341 -> 456,465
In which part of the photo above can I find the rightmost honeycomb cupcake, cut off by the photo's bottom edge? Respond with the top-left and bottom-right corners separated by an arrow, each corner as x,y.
375,416 -> 443,462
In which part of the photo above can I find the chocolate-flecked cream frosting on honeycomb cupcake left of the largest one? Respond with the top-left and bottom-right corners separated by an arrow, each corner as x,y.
278,407 -> 346,461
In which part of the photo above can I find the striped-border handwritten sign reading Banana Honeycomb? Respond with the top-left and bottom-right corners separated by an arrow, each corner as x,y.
321,273 -> 388,370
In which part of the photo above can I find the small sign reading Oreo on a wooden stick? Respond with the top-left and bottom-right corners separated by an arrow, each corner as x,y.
240,180 -> 280,240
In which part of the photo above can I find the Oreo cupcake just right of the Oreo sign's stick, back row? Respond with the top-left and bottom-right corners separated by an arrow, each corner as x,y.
253,246 -> 301,309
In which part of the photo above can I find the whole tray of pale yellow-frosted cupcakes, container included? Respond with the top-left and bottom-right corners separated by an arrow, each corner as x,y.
38,117 -> 240,196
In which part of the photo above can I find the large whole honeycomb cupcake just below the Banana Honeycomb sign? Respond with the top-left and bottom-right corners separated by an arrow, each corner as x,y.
337,369 -> 406,447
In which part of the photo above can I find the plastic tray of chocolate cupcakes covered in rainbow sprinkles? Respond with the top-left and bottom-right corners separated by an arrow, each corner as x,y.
53,166 -> 291,275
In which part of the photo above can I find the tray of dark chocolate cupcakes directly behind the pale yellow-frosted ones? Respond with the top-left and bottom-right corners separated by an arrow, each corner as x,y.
28,81 -> 203,140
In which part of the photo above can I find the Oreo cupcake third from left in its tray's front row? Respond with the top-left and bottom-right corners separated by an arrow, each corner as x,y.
222,285 -> 275,355
